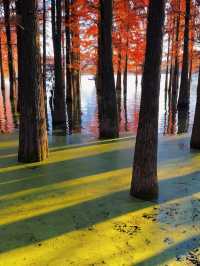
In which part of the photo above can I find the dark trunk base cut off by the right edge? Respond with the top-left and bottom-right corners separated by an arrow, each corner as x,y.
190,63 -> 200,149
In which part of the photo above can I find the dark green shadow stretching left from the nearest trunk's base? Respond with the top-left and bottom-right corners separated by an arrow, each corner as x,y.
0,190 -> 154,253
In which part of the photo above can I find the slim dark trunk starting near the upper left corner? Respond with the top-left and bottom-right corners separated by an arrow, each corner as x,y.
3,0 -> 17,107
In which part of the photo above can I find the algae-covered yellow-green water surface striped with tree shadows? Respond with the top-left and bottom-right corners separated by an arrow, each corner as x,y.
0,134 -> 200,266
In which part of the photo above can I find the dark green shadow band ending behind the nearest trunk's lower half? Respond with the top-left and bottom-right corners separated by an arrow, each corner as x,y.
0,149 -> 132,197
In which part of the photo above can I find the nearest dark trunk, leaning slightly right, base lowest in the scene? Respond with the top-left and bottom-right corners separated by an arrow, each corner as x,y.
130,0 -> 165,199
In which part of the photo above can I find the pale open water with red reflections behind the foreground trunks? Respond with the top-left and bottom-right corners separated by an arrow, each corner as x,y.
0,74 -> 197,139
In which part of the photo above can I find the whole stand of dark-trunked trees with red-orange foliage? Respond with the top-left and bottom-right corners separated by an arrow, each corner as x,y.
0,0 -> 200,198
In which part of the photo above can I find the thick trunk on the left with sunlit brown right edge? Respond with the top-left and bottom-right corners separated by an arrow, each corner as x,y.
18,0 -> 48,162
